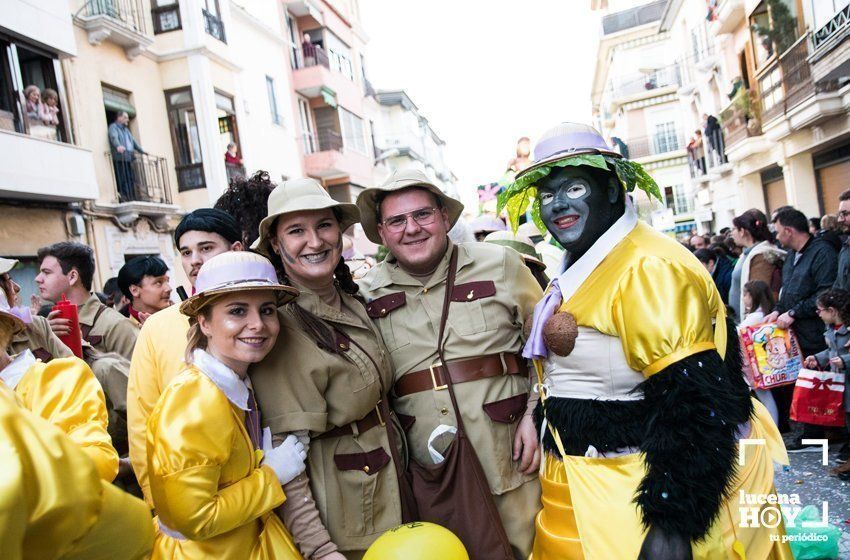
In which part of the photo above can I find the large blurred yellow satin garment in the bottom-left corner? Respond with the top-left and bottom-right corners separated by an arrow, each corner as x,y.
0,384 -> 153,560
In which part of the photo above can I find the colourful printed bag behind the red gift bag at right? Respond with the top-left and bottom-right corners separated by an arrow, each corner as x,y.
738,323 -> 803,389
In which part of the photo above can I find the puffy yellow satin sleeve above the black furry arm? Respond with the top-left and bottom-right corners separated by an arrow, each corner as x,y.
612,257 -> 726,377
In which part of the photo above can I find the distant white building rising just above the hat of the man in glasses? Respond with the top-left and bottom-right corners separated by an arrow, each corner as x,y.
374,90 -> 458,197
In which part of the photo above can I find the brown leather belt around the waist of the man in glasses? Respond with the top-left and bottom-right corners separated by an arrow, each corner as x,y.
393,352 -> 528,397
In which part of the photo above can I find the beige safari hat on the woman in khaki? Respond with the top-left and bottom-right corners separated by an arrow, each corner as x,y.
251,177 -> 360,256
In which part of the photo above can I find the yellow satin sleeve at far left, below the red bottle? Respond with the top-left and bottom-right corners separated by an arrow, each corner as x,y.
15,358 -> 118,482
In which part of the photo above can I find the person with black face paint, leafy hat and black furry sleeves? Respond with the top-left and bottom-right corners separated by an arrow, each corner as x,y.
501,123 -> 791,560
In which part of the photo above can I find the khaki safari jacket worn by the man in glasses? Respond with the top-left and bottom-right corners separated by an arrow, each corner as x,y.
358,242 -> 542,494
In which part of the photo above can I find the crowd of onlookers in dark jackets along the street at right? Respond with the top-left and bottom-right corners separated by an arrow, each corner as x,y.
687,195 -> 850,470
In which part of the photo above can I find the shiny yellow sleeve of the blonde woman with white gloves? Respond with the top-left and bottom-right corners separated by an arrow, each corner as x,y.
148,372 -> 284,540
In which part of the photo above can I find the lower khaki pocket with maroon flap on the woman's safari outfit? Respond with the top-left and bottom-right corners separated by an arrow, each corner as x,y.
334,446 -> 398,537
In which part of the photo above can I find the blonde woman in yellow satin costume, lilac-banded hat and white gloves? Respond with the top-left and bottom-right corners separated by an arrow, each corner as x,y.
147,252 -> 306,560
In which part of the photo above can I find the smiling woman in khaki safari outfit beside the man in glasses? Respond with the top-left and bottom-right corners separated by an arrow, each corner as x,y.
250,179 -> 413,560
